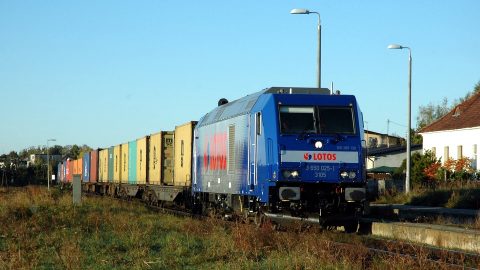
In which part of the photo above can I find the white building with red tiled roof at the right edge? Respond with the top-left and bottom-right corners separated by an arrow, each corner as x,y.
420,93 -> 480,170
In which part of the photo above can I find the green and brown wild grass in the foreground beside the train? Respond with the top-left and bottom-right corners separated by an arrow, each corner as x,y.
0,187 -> 456,269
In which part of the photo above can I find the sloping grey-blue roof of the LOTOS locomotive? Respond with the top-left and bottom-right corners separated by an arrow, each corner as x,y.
198,87 -> 330,126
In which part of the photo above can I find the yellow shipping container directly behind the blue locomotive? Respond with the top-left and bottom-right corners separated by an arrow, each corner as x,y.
173,121 -> 197,186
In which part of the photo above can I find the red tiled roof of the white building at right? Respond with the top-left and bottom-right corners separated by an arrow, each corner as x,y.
420,92 -> 480,133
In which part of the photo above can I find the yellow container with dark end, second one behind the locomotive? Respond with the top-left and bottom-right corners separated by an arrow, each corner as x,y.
148,131 -> 174,185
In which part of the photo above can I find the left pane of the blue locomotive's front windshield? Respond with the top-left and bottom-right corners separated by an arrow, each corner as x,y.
280,106 -> 317,134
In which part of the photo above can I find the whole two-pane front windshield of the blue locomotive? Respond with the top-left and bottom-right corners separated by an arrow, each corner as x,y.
280,106 -> 355,134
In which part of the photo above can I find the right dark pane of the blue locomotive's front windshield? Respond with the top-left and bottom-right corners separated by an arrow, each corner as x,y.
318,107 -> 355,134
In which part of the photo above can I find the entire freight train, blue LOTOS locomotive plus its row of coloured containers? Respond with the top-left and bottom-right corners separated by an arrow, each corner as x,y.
58,87 -> 366,231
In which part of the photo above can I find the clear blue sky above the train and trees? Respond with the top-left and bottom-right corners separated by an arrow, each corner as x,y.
0,0 -> 480,154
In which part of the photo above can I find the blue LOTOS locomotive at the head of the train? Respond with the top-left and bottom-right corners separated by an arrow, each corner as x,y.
192,87 -> 366,231
